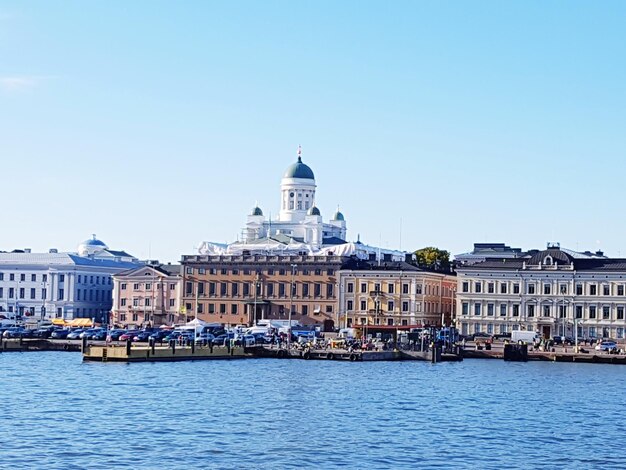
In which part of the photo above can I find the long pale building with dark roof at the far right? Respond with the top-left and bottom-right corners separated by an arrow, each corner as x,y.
457,244 -> 626,339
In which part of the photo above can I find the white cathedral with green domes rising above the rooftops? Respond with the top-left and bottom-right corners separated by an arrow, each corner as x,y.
243,149 -> 346,246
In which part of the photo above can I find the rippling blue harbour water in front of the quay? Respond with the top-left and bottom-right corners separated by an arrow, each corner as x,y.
0,352 -> 626,469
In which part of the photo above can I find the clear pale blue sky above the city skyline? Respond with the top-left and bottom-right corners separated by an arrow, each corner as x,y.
0,0 -> 626,261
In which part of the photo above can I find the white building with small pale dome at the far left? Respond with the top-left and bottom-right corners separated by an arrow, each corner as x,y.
0,236 -> 140,322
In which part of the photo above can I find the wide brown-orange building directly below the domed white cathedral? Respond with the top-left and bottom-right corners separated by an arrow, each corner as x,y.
182,255 -> 346,329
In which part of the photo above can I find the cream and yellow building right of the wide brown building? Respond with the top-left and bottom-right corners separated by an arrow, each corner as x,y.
339,260 -> 457,327
